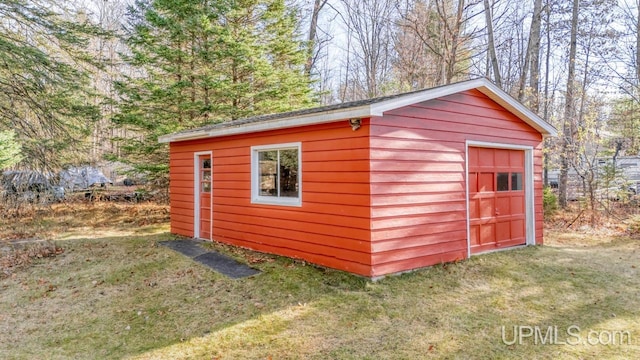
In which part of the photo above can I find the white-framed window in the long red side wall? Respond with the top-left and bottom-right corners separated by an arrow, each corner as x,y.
251,143 -> 302,206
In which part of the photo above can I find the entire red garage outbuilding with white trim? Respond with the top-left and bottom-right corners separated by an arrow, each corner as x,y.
160,79 -> 556,277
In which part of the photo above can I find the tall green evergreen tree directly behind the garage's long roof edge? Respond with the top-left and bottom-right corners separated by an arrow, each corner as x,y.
114,0 -> 312,183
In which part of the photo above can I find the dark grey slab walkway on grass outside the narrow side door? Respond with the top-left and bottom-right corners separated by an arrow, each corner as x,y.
158,240 -> 260,279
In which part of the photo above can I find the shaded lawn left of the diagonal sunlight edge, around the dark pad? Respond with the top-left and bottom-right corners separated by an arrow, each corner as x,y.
0,233 -> 366,358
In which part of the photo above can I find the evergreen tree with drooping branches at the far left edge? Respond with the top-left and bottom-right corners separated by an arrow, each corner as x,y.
0,0 -> 104,169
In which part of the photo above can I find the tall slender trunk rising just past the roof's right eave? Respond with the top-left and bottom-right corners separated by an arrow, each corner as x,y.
558,0 -> 580,209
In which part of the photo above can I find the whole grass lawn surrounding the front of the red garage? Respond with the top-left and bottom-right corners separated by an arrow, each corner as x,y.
0,204 -> 640,359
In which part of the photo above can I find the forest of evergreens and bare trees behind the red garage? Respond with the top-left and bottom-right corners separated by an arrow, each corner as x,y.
0,0 -> 640,215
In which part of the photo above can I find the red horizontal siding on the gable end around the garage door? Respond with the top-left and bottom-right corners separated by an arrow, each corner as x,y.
371,90 -> 542,276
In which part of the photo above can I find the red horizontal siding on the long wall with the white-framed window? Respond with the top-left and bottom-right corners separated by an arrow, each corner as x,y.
170,120 -> 371,276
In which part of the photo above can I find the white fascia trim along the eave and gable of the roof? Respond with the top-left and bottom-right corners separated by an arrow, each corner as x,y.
158,78 -> 557,143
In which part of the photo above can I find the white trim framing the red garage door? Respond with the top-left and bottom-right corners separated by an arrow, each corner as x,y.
464,140 -> 536,257
